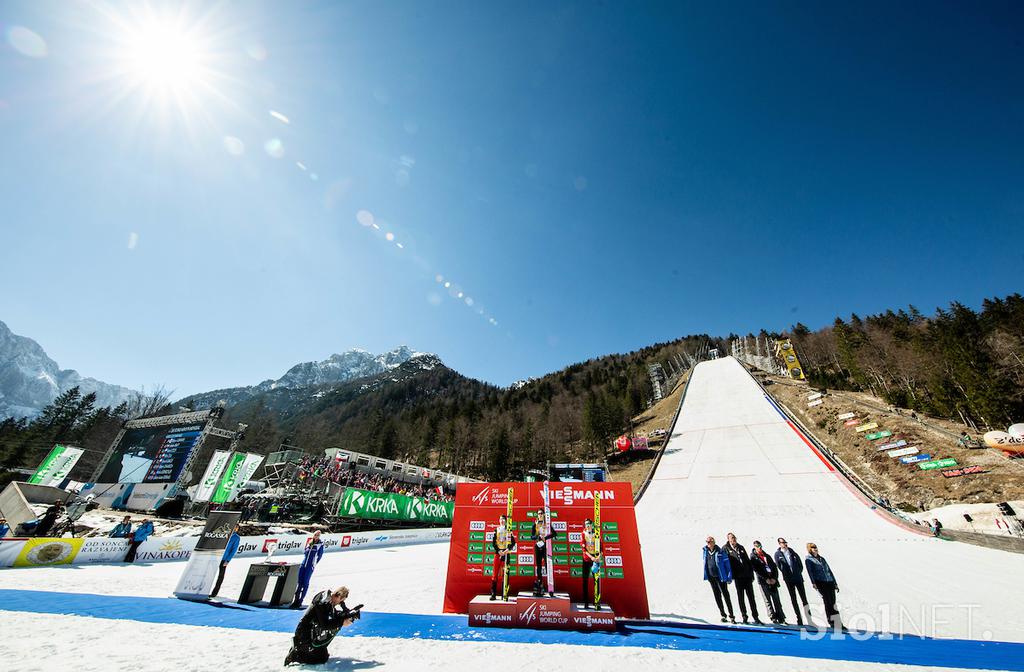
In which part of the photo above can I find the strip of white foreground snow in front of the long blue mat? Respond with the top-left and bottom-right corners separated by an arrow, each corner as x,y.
0,612 -> 999,672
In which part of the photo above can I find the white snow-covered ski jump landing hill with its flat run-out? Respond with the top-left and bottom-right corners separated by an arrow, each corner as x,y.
636,358 -> 1024,641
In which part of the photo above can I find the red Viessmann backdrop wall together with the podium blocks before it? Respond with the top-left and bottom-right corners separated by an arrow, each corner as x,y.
444,482 -> 650,630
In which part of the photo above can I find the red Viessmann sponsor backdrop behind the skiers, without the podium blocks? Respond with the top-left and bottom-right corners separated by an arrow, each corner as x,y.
444,482 -> 650,619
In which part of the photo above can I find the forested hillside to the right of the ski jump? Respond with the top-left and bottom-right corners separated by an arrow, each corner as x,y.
792,294 -> 1024,429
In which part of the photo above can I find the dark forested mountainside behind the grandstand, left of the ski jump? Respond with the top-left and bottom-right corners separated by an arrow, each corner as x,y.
214,336 -> 720,479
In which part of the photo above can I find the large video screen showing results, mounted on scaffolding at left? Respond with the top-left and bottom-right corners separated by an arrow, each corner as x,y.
97,423 -> 203,482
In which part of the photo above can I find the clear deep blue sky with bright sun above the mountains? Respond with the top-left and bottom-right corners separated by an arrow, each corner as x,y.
0,1 -> 1024,394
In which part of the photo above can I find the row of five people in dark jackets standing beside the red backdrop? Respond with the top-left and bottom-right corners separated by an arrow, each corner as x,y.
703,532 -> 843,629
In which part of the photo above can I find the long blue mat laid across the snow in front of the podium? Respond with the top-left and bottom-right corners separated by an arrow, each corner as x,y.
0,590 -> 1024,672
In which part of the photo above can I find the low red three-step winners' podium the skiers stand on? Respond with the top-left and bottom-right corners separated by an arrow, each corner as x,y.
469,592 -> 615,632
